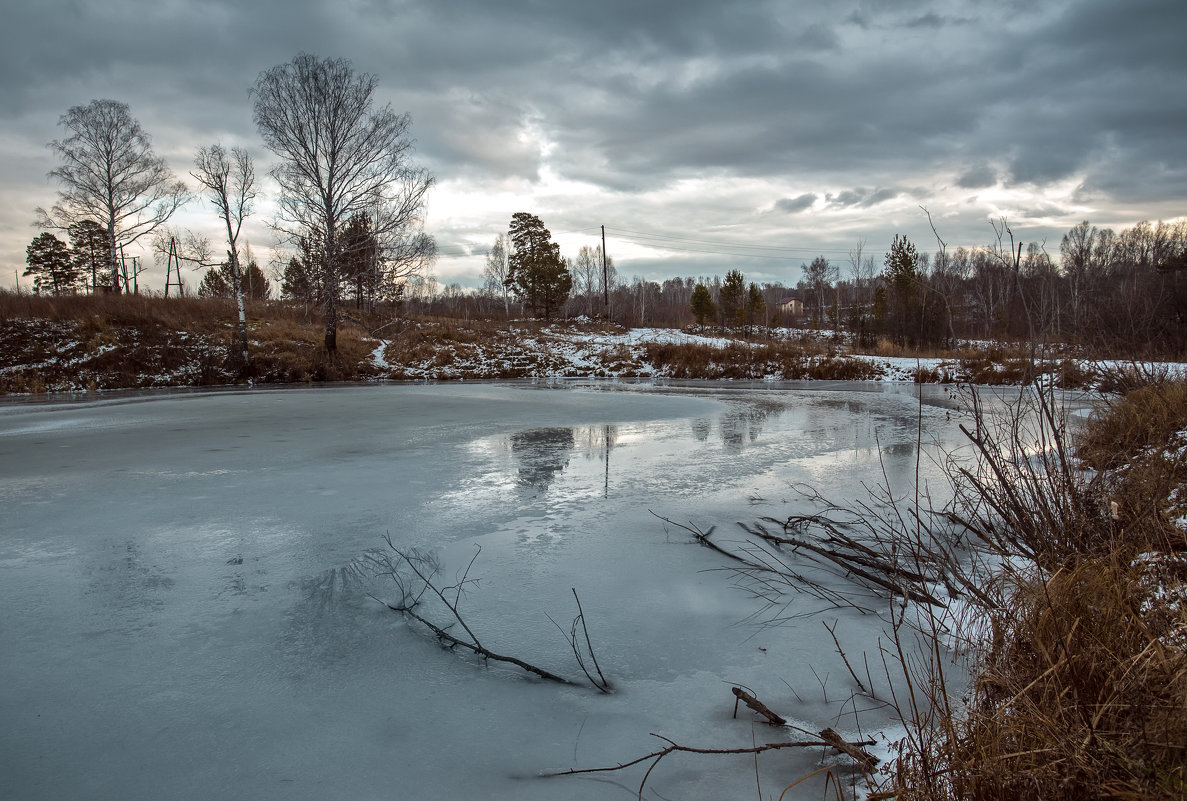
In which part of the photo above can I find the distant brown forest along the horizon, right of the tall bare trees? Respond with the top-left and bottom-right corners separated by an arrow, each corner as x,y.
407,220 -> 1187,356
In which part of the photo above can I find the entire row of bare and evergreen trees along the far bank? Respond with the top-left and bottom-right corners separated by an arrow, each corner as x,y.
25,53 -> 1187,362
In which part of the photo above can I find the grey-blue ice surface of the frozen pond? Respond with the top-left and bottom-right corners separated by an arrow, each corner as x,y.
0,383 -> 973,801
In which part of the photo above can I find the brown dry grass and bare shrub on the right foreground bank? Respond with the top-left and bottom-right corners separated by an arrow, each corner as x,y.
893,382 -> 1187,801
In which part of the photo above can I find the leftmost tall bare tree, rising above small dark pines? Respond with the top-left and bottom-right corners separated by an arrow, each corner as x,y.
37,100 -> 189,293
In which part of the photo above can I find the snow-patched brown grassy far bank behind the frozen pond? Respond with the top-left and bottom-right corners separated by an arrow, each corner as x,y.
0,292 -> 1168,394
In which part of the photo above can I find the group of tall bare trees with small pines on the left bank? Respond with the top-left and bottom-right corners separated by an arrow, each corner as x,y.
25,53 -> 436,363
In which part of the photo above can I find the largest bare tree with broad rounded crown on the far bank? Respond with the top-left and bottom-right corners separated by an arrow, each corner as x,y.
252,53 -> 433,352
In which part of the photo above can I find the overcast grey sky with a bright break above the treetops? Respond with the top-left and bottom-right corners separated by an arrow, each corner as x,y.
0,0 -> 1187,291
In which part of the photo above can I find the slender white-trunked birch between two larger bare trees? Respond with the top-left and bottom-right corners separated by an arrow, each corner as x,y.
190,145 -> 255,365
